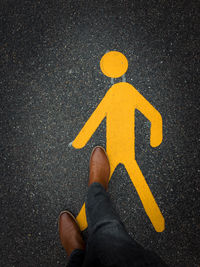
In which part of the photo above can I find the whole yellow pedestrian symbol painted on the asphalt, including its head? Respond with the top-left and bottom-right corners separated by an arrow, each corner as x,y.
72,51 -> 165,232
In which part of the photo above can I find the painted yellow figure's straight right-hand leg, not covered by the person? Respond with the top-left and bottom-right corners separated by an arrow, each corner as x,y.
125,160 -> 165,232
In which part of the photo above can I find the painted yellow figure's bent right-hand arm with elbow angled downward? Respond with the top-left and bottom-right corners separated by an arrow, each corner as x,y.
136,92 -> 163,147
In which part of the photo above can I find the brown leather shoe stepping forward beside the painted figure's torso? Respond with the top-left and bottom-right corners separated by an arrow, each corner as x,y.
88,146 -> 110,190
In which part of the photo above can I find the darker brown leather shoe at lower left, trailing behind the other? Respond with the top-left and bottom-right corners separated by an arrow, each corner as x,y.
59,211 -> 85,256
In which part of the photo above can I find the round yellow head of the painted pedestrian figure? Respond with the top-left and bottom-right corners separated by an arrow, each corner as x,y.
100,51 -> 128,78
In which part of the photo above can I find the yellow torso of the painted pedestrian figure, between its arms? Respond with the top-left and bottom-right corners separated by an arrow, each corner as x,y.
105,83 -> 137,163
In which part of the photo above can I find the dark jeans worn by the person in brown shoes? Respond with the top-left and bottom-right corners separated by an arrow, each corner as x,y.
67,183 -> 166,267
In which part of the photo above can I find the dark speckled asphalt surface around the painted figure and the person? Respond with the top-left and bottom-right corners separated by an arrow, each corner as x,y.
0,0 -> 200,267
